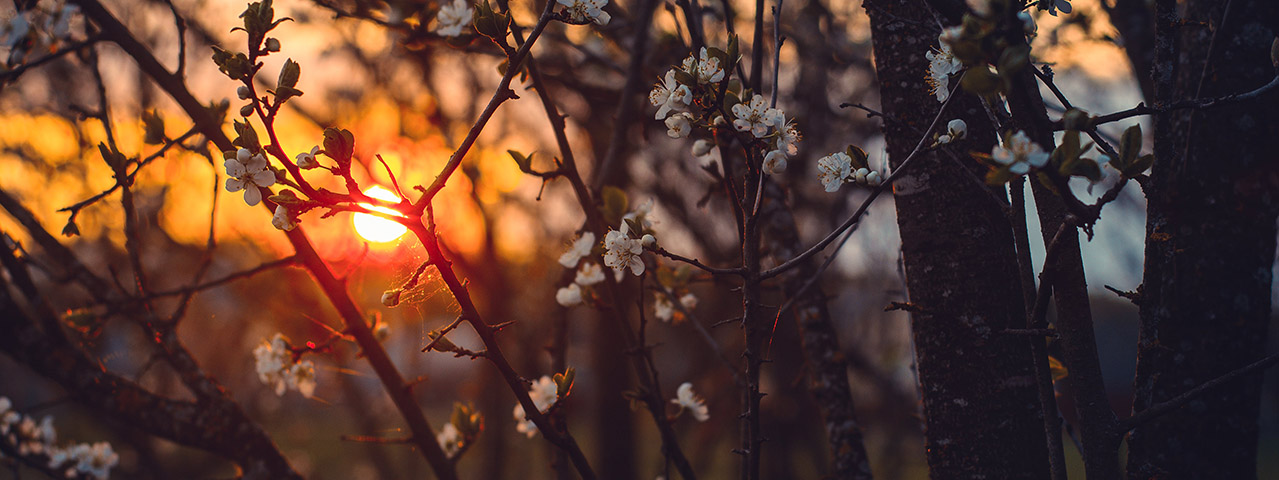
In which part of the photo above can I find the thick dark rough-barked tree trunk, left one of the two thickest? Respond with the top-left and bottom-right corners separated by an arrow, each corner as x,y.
867,0 -> 1049,479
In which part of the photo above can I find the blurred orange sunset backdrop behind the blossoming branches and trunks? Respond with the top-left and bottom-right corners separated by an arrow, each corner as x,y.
0,0 -> 1279,479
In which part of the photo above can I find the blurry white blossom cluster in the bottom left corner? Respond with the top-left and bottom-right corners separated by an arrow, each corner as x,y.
0,397 -> 120,480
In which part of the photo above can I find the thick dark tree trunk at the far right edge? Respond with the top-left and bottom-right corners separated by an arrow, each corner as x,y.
1128,0 -> 1279,479
